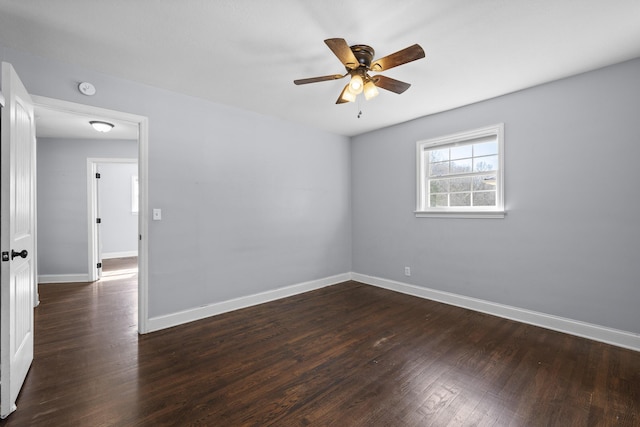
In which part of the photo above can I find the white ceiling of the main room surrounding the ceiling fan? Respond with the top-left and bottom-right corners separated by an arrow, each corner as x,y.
0,0 -> 640,136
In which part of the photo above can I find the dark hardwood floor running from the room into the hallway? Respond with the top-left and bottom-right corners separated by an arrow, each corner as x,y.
0,260 -> 640,426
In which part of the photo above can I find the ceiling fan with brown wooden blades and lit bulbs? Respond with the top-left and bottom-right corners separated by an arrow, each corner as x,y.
293,39 -> 425,104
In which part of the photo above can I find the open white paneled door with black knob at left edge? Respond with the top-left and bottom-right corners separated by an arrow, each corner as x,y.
0,62 -> 36,418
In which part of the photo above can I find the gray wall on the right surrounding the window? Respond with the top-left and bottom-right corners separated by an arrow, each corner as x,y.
352,60 -> 640,333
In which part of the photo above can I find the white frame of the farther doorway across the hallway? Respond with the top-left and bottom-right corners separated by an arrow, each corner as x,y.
87,157 -> 140,282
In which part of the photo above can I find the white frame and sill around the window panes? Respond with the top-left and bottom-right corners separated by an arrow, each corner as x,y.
415,123 -> 505,218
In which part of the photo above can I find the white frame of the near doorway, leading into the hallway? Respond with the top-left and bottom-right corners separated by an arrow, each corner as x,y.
32,95 -> 149,334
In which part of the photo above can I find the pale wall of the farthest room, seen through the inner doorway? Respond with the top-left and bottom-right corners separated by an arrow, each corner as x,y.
97,163 -> 138,258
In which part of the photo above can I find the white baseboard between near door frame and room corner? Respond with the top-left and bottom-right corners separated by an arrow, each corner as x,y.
147,273 -> 351,332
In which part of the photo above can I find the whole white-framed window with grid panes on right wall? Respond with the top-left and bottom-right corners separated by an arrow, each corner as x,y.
416,124 -> 504,218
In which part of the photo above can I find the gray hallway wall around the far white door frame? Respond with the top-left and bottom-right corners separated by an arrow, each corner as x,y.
37,138 -> 138,275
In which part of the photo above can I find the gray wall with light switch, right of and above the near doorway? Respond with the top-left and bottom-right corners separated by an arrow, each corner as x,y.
0,46 -> 351,317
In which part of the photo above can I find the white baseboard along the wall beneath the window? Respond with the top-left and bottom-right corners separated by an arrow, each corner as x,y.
351,273 -> 640,351
